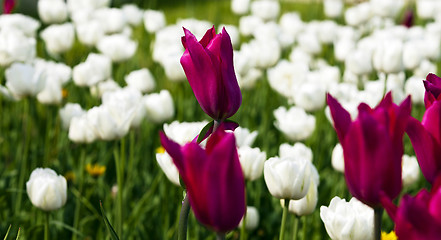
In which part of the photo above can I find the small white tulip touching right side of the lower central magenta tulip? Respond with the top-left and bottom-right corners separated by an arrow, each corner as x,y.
238,146 -> 266,181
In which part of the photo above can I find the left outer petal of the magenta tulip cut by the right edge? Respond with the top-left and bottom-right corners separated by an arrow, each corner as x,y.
406,117 -> 441,182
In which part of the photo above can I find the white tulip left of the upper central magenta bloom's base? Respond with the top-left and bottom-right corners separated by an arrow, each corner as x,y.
143,90 -> 175,123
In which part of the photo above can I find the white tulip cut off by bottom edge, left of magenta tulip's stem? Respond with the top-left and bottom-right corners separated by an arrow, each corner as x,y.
320,197 -> 374,240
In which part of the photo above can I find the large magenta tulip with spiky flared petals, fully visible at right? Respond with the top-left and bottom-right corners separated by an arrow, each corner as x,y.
327,92 -> 411,208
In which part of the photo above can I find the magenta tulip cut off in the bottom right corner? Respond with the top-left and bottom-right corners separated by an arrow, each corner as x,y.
382,176 -> 441,240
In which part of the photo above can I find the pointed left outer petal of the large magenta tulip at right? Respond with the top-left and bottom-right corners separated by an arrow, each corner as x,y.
326,93 -> 351,142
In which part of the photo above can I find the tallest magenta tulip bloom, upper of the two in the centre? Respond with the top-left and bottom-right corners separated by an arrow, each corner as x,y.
181,27 -> 242,121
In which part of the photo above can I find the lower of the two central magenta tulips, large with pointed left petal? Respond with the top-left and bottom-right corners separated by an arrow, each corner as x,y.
161,125 -> 245,233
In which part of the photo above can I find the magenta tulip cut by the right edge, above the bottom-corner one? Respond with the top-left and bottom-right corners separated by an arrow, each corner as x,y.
406,74 -> 441,183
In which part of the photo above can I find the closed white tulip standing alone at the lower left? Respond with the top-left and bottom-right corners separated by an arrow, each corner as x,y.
26,168 -> 67,211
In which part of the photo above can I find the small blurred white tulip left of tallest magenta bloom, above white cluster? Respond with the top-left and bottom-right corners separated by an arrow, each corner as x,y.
124,68 -> 156,93
